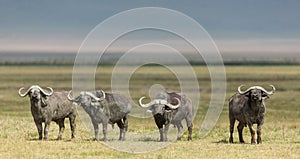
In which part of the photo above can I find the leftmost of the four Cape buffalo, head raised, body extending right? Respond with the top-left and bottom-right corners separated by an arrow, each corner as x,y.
19,85 -> 77,140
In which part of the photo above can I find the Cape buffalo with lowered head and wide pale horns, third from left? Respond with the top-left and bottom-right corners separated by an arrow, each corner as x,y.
139,92 -> 193,141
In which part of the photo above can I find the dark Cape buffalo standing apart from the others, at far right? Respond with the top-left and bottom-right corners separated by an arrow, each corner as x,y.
229,85 -> 275,144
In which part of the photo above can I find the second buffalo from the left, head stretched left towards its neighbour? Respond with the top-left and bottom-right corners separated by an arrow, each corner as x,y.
68,90 -> 132,141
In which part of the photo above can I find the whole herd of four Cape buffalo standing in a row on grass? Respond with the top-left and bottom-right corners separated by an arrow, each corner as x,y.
18,85 -> 275,144
